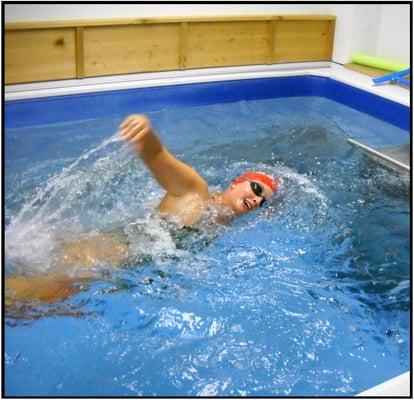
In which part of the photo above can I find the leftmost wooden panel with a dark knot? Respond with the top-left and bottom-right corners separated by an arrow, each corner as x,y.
5,28 -> 76,84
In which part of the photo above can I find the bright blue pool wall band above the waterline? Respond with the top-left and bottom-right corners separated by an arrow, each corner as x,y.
4,75 -> 411,131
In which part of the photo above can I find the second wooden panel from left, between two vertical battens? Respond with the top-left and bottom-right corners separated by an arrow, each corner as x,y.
84,24 -> 180,76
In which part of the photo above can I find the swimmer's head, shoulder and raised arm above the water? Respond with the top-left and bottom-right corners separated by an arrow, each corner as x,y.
120,115 -> 277,226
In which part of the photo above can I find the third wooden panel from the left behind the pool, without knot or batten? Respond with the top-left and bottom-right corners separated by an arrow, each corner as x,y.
187,21 -> 268,68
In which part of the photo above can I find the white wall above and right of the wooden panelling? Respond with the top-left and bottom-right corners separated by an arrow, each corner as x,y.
4,3 -> 411,64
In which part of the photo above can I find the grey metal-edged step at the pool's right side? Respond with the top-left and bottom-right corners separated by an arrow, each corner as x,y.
348,139 -> 411,173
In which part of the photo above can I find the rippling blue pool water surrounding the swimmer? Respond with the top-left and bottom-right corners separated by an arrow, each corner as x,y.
5,97 -> 410,396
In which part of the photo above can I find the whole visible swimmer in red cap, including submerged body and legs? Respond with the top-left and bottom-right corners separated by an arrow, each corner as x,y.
6,114 -> 278,305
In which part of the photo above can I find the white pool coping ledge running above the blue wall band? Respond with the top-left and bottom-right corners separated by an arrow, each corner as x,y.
5,62 -> 410,106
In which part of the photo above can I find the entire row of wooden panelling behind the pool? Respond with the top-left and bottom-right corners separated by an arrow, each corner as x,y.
5,15 -> 335,84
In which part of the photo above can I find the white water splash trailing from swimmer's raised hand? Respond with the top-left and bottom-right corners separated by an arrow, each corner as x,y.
5,132 -> 142,272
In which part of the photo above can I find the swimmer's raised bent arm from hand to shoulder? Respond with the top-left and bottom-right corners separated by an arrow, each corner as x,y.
120,114 -> 208,196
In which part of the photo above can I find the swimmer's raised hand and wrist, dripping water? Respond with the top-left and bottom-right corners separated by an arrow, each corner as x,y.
119,114 -> 162,156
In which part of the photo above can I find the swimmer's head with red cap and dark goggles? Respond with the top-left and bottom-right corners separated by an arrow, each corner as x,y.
224,171 -> 278,215
